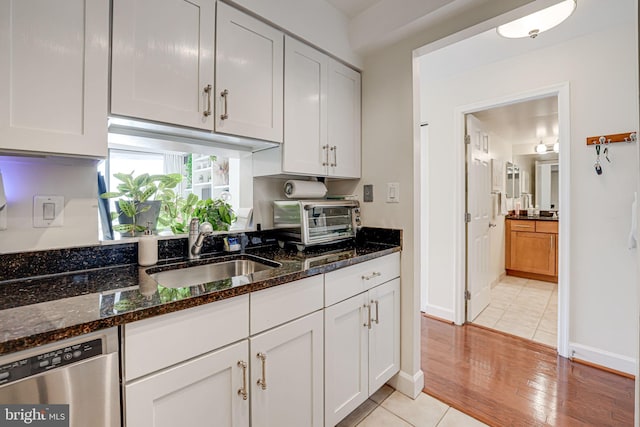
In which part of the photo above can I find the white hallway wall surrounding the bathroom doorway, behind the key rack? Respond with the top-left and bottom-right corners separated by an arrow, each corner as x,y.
421,0 -> 638,372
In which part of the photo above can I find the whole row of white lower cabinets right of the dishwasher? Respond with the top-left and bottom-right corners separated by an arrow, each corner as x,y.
122,254 -> 400,427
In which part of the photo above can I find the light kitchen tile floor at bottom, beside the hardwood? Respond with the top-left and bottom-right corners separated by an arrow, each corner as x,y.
337,385 -> 486,427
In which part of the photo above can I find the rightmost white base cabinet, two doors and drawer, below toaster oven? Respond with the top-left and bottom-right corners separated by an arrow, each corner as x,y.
324,254 -> 400,426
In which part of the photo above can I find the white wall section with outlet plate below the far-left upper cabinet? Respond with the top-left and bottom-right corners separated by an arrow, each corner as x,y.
0,157 -> 98,253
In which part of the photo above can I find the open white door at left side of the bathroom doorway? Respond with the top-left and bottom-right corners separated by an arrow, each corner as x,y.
466,114 -> 491,321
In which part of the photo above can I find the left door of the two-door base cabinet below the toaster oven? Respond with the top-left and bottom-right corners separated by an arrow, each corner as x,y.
324,293 -> 369,427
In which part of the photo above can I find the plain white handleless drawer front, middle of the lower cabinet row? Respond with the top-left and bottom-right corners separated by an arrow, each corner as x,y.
250,275 -> 324,335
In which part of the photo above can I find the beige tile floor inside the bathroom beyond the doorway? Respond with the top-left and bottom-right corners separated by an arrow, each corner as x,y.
472,276 -> 558,347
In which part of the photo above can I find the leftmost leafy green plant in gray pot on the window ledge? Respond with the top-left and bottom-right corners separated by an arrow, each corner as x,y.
100,171 -> 182,235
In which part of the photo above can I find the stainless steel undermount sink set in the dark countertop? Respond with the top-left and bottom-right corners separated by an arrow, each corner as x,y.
149,259 -> 276,288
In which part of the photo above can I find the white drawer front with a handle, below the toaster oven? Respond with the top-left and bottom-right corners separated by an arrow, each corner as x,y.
324,252 -> 400,307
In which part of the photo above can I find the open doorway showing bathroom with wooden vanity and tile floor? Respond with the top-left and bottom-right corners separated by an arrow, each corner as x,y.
464,95 -> 561,348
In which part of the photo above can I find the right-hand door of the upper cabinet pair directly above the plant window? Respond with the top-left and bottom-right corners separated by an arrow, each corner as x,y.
215,3 -> 284,142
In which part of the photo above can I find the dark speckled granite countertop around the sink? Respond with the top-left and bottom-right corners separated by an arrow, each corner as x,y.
0,236 -> 401,354
